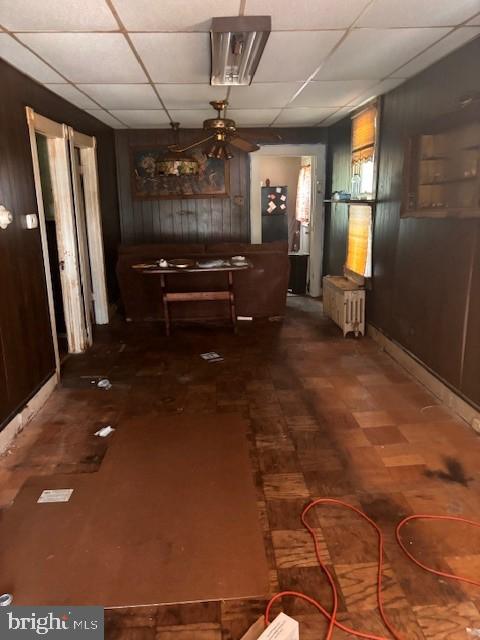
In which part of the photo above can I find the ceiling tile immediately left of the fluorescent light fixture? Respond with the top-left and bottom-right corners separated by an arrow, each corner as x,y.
131,33 -> 210,84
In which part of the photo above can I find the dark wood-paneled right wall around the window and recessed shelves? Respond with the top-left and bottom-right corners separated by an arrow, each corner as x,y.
326,38 -> 480,405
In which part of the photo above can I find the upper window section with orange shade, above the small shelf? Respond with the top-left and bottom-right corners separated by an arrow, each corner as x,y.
351,103 -> 377,200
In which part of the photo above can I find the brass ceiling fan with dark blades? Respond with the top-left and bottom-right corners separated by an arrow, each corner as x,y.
168,100 -> 281,160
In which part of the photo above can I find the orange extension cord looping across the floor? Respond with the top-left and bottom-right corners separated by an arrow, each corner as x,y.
265,498 -> 480,640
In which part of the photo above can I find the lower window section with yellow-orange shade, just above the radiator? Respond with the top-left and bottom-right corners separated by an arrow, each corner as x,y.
345,204 -> 372,278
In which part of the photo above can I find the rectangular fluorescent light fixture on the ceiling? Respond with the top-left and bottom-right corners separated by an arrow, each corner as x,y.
210,16 -> 272,86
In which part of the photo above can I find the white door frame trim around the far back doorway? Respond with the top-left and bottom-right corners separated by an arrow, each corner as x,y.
250,143 -> 326,297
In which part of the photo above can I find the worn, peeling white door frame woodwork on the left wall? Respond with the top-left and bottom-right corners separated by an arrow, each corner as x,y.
25,107 -> 108,362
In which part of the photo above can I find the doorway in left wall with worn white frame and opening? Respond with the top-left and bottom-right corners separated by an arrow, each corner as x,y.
26,107 -> 108,372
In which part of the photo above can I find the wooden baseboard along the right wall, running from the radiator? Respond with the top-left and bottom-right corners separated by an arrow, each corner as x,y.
367,324 -> 480,432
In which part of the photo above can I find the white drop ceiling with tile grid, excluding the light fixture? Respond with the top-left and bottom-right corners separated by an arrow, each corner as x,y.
0,0 -> 480,129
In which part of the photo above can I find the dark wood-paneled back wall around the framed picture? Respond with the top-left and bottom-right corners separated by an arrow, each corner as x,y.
115,128 -> 325,244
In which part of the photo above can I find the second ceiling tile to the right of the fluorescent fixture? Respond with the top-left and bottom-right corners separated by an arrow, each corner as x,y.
315,27 -> 449,80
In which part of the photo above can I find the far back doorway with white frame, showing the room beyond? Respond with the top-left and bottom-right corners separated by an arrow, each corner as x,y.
250,144 -> 325,297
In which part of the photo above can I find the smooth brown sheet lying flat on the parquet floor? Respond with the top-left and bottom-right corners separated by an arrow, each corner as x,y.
0,414 -> 268,607
